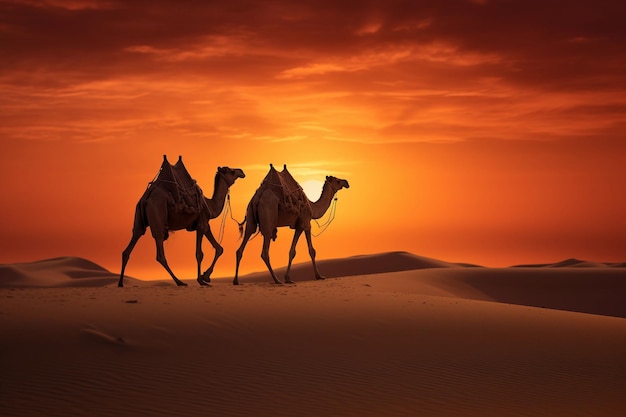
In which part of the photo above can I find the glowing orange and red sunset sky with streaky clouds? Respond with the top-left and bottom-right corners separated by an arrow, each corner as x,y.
0,0 -> 626,279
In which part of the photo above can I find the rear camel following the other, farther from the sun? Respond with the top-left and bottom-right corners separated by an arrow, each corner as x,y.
118,156 -> 246,287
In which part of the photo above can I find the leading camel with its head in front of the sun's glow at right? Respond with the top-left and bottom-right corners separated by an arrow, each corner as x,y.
233,164 -> 350,285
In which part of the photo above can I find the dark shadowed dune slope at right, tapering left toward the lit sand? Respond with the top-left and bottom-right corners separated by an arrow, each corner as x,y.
360,268 -> 626,318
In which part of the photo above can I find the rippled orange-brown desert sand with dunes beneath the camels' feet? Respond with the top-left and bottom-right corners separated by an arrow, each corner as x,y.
0,252 -> 626,416
